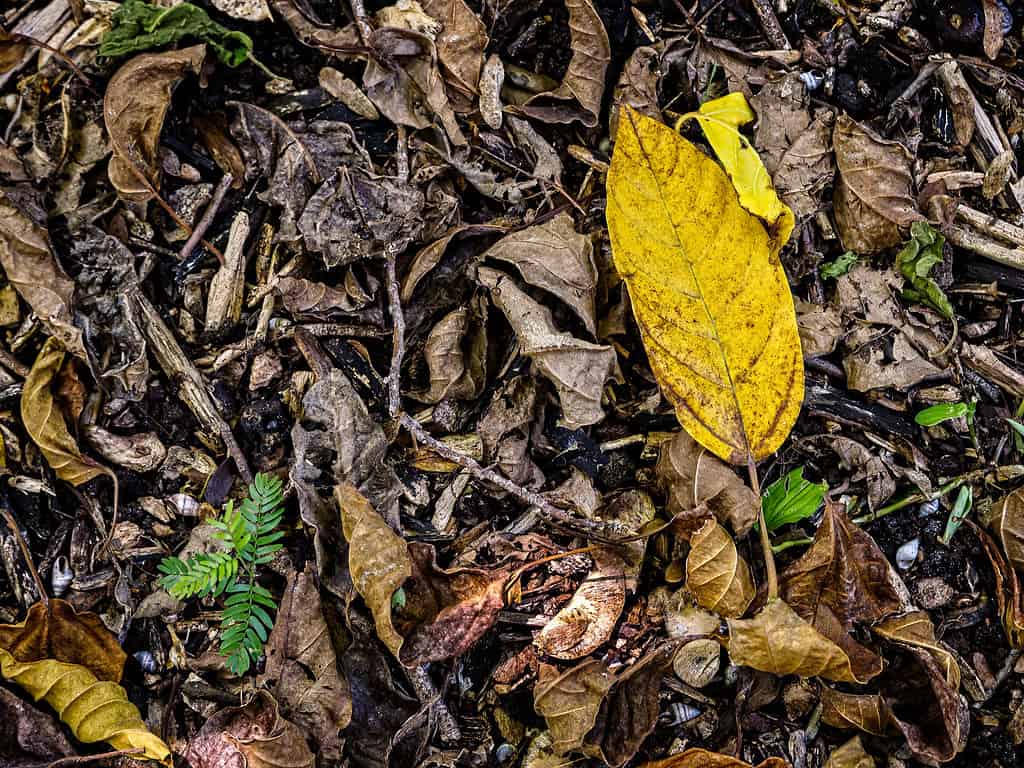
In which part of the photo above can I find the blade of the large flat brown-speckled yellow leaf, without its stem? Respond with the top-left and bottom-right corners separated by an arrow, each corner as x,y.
607,109 -> 804,464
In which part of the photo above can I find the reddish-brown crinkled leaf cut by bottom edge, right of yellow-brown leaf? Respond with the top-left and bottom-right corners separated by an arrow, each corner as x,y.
184,691 -> 315,768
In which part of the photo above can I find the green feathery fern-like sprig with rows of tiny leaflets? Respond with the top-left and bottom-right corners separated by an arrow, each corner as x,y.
159,473 -> 285,676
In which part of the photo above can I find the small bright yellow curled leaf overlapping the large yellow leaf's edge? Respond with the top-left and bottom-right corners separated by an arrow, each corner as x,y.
682,92 -> 795,255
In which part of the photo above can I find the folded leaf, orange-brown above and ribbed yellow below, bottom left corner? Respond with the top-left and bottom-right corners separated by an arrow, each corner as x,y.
0,599 -> 171,766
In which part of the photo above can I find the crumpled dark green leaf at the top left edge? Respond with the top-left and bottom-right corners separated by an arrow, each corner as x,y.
99,0 -> 253,67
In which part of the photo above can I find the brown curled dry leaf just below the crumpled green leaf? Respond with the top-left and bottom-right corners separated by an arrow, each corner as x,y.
103,45 -> 206,202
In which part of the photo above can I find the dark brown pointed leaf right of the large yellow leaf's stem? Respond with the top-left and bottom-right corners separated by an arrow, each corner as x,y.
779,502 -> 900,631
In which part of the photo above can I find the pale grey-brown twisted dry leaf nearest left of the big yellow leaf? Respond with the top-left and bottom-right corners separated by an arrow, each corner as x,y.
478,267 -> 617,429
